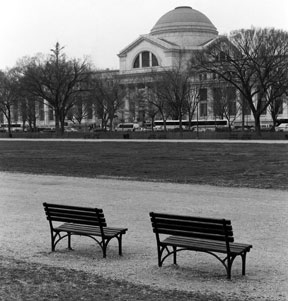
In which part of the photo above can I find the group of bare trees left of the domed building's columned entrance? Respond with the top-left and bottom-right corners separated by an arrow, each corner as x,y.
0,43 -> 124,134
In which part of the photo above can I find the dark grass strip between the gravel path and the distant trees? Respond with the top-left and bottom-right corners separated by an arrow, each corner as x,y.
0,140 -> 288,189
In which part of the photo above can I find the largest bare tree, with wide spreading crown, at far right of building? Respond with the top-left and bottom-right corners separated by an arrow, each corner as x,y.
191,28 -> 288,135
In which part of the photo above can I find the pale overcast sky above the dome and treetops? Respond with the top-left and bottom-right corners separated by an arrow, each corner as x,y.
0,0 -> 288,70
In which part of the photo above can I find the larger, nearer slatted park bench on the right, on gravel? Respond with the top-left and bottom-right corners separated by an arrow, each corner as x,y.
150,212 -> 252,279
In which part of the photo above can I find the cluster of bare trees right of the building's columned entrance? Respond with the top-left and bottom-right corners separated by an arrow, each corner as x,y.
146,28 -> 288,135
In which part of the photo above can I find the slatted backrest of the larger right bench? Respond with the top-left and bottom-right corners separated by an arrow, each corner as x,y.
150,212 -> 234,243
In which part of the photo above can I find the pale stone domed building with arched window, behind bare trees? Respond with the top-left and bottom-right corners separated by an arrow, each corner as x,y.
118,6 -> 225,123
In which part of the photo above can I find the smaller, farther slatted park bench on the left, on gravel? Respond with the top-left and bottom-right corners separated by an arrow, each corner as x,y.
43,203 -> 128,258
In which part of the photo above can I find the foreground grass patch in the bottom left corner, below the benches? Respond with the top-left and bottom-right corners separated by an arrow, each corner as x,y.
0,258 -> 227,301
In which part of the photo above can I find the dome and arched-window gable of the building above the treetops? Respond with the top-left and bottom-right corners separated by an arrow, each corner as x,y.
118,6 -> 218,74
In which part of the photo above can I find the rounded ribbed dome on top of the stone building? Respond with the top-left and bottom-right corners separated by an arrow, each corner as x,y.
150,6 -> 218,47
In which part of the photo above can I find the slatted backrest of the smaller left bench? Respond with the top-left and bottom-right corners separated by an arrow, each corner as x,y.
43,203 -> 107,228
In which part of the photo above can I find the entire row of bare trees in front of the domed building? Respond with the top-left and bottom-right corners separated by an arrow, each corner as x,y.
0,28 -> 288,133
